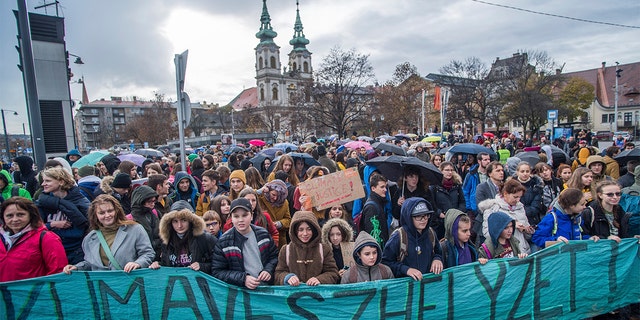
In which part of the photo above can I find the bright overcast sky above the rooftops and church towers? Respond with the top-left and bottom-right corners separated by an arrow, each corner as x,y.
0,0 -> 640,133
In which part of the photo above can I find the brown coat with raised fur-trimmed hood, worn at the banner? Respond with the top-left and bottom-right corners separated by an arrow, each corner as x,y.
275,211 -> 340,285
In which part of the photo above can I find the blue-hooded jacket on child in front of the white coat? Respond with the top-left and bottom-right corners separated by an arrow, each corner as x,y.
478,212 -> 521,259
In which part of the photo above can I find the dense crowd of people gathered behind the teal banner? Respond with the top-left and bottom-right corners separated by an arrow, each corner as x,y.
0,135 -> 640,318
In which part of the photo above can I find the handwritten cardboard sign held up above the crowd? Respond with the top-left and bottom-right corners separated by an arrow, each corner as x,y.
298,168 -> 364,210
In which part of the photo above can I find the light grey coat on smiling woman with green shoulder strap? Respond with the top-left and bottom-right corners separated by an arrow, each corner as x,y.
76,223 -> 155,271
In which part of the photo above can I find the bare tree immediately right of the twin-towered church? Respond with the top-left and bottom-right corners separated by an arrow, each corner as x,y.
309,47 -> 375,136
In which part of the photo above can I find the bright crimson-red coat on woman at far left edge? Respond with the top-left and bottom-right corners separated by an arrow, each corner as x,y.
0,226 -> 67,282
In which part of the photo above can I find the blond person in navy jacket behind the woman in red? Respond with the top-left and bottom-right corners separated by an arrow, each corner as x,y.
36,168 -> 90,264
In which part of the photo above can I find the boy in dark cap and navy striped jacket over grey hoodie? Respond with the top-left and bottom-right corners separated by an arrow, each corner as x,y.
211,198 -> 278,289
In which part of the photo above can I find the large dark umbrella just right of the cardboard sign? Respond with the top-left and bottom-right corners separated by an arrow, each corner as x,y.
367,155 -> 442,186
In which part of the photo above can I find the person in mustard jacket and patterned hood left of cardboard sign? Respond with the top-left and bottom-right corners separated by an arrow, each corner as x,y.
257,179 -> 291,248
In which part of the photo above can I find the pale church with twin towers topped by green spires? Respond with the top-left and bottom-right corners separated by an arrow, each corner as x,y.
229,0 -> 313,138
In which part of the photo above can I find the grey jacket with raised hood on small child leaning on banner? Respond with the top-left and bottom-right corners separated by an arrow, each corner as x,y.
340,231 -> 393,283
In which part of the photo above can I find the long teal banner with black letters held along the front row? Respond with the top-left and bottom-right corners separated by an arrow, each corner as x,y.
0,239 -> 640,319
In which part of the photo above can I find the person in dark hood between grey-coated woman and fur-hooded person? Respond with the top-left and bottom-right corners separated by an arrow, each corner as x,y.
127,186 -> 162,261
